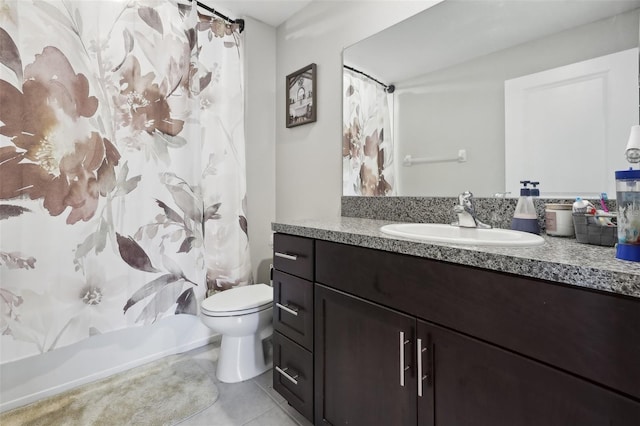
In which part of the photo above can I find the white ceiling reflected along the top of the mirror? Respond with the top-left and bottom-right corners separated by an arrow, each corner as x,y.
344,0 -> 640,85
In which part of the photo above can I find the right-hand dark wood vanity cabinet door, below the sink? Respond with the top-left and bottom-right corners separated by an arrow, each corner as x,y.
416,321 -> 640,426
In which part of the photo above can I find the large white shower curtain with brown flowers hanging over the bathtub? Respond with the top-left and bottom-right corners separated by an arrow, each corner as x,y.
0,0 -> 252,362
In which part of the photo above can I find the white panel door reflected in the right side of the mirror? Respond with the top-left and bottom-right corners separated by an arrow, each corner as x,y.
505,48 -> 639,198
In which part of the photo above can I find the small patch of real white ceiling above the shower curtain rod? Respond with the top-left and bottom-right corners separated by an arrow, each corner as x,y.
198,0 -> 317,27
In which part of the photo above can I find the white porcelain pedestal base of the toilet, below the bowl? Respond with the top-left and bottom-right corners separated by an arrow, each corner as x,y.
216,334 -> 272,383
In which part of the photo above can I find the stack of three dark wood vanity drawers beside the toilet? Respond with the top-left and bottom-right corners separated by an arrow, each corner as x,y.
273,234 -> 314,420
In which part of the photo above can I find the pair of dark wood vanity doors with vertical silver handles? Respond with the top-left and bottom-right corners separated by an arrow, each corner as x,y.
315,284 -> 640,426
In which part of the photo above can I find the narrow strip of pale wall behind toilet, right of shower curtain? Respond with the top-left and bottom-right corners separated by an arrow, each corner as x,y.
244,18 -> 276,283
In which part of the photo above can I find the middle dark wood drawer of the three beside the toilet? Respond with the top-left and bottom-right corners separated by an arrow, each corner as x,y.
273,270 -> 313,350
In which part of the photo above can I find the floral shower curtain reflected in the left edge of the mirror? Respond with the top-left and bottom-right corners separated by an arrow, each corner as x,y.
342,68 -> 395,196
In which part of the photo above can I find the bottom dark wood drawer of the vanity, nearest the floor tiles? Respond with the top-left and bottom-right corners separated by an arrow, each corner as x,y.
273,332 -> 313,422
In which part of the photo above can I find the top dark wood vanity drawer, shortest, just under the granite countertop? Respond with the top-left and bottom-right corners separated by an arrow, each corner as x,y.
273,234 -> 314,281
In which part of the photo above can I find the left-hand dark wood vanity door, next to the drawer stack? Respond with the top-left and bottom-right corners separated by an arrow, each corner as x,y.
314,284 -> 417,426
